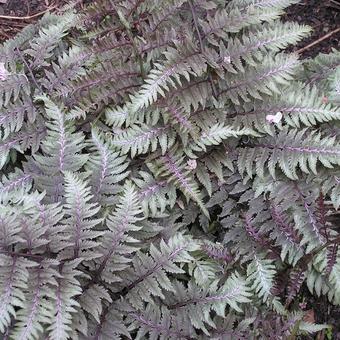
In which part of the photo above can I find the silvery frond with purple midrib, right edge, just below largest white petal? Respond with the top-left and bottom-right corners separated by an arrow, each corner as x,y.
238,129 -> 340,179
